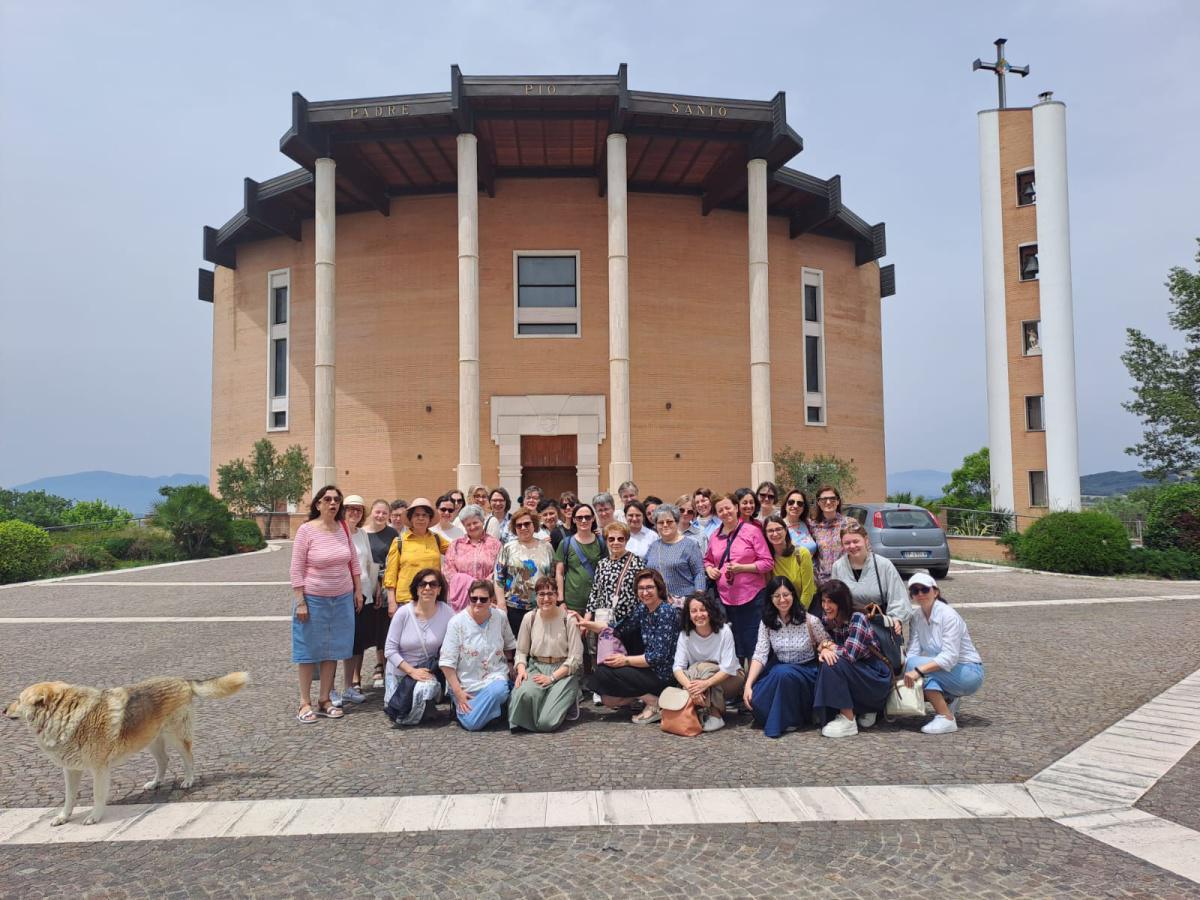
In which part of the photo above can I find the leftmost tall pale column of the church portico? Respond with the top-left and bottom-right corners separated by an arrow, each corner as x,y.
312,157 -> 337,491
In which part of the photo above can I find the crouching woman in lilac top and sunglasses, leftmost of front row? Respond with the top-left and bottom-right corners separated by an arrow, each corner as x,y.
383,569 -> 453,725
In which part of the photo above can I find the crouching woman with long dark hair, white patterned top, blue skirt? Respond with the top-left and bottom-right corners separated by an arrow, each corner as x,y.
742,576 -> 829,738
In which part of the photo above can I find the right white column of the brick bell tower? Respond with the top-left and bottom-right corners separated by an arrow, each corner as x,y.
1033,101 -> 1080,510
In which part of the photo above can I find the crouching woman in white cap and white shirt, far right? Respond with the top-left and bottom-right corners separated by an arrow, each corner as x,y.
904,572 -> 983,734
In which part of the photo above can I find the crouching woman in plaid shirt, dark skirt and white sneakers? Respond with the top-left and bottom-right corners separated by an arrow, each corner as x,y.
812,578 -> 893,738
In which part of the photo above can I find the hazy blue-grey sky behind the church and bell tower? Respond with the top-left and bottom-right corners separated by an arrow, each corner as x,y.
0,0 -> 1200,485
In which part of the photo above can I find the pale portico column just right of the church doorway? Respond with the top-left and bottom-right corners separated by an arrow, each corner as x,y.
607,134 -> 634,494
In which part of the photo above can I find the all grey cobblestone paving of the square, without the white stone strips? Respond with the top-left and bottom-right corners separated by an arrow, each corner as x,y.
0,550 -> 1200,896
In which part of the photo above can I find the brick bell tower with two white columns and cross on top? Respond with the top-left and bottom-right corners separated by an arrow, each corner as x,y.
972,38 -> 1080,516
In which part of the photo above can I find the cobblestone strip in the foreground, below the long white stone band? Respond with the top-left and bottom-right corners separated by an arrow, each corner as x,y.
0,821 -> 1200,899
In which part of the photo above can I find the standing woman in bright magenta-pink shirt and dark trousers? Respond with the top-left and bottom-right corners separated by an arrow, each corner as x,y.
704,494 -> 775,660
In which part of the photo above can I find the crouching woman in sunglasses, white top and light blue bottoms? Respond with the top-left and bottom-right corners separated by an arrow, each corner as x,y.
438,580 -> 517,731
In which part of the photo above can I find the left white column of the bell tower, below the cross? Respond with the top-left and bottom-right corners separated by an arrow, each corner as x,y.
979,109 -> 1016,510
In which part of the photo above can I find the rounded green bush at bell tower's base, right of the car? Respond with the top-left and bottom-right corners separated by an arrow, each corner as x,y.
1015,512 -> 1129,575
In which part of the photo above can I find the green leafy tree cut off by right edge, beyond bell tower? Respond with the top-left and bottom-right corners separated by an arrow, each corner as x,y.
1121,239 -> 1200,480
